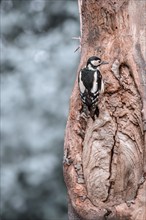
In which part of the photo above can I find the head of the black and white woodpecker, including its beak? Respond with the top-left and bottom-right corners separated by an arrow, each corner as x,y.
86,56 -> 108,70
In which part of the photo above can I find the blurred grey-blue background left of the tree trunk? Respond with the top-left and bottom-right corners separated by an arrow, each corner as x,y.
0,0 -> 80,220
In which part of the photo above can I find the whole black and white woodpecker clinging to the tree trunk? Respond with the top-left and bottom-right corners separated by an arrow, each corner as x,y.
78,56 -> 107,120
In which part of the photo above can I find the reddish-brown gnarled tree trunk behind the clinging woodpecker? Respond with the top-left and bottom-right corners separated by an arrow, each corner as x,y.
64,0 -> 146,220
